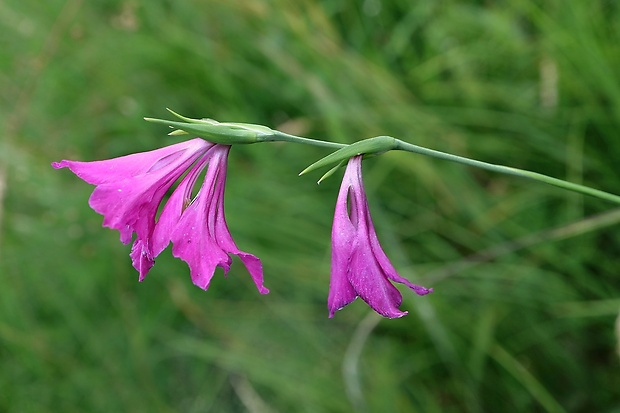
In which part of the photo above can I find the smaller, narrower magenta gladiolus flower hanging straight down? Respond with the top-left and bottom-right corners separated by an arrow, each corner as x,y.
327,156 -> 433,318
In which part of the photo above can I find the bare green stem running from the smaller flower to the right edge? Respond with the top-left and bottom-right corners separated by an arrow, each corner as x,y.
394,139 -> 620,204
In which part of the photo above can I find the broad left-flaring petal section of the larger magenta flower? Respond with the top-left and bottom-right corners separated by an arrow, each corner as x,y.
52,139 -> 214,281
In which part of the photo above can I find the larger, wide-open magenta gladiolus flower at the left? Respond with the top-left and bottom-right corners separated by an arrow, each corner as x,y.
52,138 -> 269,294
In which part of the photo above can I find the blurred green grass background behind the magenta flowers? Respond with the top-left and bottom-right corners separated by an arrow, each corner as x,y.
0,0 -> 620,413
